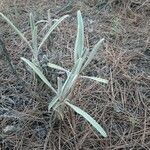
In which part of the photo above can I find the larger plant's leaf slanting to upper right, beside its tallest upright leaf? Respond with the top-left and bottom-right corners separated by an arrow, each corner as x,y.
82,38 -> 104,69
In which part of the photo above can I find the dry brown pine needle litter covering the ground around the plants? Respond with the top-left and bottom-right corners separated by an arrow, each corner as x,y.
0,0 -> 150,150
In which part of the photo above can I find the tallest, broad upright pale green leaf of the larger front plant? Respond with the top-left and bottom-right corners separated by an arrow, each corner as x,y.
74,11 -> 84,63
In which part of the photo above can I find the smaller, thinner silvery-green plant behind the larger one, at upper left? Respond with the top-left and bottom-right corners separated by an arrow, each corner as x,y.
0,11 -> 68,67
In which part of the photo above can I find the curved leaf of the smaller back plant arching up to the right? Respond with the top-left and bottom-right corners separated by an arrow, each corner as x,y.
38,15 -> 69,49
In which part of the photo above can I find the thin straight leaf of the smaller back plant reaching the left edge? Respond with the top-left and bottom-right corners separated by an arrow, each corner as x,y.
0,13 -> 32,50
